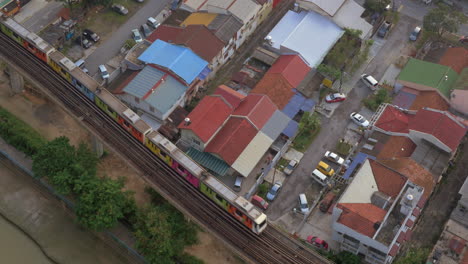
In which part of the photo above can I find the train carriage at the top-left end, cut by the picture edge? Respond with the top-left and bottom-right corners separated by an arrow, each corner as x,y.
0,18 -> 55,63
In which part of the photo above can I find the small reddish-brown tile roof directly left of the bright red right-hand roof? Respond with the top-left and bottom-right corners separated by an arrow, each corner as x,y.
377,136 -> 416,159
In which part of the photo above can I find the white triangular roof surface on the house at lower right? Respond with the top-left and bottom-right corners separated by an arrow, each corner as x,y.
339,160 -> 379,203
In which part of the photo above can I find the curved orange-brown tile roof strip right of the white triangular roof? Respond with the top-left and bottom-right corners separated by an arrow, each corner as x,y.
379,158 -> 436,199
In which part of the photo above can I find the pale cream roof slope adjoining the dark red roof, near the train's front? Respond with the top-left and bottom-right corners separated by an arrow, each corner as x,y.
232,132 -> 274,177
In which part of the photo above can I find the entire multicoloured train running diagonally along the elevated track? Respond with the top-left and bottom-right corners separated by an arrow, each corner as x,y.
0,17 -> 268,235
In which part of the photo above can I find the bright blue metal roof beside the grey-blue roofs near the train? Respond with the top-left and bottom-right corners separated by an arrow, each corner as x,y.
138,39 -> 208,84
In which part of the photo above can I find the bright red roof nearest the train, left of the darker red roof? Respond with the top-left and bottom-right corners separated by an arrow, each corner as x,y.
179,96 -> 232,143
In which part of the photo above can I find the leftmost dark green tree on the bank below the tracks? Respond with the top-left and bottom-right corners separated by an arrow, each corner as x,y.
32,137 -> 75,178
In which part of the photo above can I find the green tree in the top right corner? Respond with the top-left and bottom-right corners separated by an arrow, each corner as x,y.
423,5 -> 467,39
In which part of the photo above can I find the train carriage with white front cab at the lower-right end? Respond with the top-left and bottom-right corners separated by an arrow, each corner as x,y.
200,175 -> 267,234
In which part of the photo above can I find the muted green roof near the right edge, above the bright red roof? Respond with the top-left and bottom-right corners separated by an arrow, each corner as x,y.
398,58 -> 458,98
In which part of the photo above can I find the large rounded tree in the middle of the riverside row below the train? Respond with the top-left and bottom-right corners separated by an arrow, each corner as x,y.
74,177 -> 134,231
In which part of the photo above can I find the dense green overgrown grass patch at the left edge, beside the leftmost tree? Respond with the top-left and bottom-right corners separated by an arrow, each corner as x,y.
0,107 -> 47,156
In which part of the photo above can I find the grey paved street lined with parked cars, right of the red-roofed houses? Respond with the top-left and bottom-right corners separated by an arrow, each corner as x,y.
268,15 -> 418,221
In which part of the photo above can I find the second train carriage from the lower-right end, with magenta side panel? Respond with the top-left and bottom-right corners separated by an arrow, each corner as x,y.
145,131 -> 204,189
